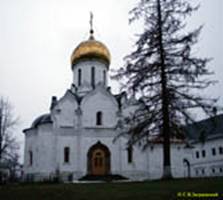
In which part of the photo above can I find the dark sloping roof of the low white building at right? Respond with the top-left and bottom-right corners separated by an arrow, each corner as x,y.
185,114 -> 223,142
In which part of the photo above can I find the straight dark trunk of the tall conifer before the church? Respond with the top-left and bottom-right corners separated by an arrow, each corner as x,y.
157,0 -> 172,179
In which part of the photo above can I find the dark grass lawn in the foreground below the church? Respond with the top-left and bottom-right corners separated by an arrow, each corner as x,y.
0,178 -> 223,200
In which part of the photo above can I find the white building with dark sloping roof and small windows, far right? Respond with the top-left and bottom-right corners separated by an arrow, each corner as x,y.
187,114 -> 223,177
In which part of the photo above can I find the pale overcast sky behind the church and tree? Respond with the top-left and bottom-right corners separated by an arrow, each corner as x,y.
0,0 -> 223,159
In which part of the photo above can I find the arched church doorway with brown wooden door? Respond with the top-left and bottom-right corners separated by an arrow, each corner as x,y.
87,142 -> 111,176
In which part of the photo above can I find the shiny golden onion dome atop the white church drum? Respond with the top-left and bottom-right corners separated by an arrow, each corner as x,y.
71,36 -> 111,68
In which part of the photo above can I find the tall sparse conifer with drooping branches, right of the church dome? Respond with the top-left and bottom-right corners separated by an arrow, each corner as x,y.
115,0 -> 216,179
